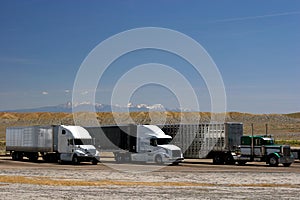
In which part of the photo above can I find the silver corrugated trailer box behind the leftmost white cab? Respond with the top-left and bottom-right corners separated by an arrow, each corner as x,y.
6,126 -> 54,152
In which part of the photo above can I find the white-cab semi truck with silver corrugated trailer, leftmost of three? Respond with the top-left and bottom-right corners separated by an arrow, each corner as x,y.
6,125 -> 100,164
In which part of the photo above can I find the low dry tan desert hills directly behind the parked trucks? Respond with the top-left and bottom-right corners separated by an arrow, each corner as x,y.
0,112 -> 300,141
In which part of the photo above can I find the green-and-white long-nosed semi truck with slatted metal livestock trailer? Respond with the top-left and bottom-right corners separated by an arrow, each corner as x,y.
160,122 -> 294,167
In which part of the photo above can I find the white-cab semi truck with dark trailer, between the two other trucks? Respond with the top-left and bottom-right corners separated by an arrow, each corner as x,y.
85,124 -> 183,164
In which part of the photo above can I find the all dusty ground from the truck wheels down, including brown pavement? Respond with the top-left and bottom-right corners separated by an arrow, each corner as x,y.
0,157 -> 300,200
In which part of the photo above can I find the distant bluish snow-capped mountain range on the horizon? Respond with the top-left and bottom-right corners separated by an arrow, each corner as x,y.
6,102 -> 188,113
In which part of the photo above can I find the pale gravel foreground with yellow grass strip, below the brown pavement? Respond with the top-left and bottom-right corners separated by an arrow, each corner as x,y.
0,164 -> 300,200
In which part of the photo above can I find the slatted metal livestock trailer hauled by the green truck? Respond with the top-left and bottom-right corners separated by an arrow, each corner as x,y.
160,122 -> 243,164
